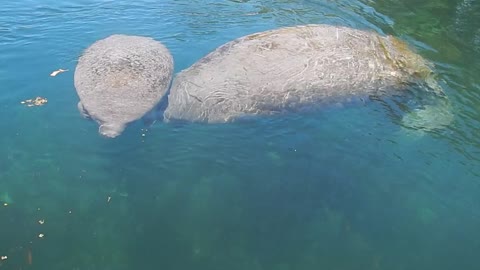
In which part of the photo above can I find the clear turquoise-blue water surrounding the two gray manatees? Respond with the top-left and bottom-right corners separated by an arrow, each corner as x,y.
0,0 -> 480,270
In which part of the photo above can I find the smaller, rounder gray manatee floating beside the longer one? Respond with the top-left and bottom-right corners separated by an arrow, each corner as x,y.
74,35 -> 174,138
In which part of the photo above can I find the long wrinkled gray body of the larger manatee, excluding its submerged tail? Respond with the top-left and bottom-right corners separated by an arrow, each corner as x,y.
164,25 -> 438,123
